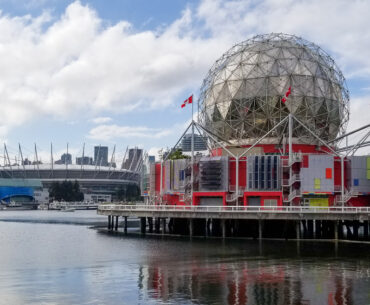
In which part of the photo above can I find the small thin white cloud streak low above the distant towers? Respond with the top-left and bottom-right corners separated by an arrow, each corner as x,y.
88,124 -> 172,141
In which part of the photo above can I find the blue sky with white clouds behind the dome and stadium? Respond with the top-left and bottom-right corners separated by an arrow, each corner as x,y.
0,0 -> 370,163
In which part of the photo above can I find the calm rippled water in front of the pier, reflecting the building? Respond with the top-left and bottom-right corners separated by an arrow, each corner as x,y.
0,211 -> 370,305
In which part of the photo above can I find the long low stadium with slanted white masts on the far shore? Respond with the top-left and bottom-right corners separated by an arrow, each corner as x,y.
0,146 -> 143,203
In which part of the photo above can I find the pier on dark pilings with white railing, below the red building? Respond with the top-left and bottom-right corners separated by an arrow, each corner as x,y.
98,204 -> 370,241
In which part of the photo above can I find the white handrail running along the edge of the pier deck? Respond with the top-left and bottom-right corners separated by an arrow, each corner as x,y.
98,204 -> 370,214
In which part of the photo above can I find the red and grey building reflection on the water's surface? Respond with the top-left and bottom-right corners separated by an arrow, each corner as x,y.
139,261 -> 362,305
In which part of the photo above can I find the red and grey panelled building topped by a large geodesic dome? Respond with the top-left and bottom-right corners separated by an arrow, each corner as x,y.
144,33 -> 370,207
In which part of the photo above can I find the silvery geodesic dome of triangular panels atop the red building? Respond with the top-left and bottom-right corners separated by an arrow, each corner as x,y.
199,34 -> 349,144
